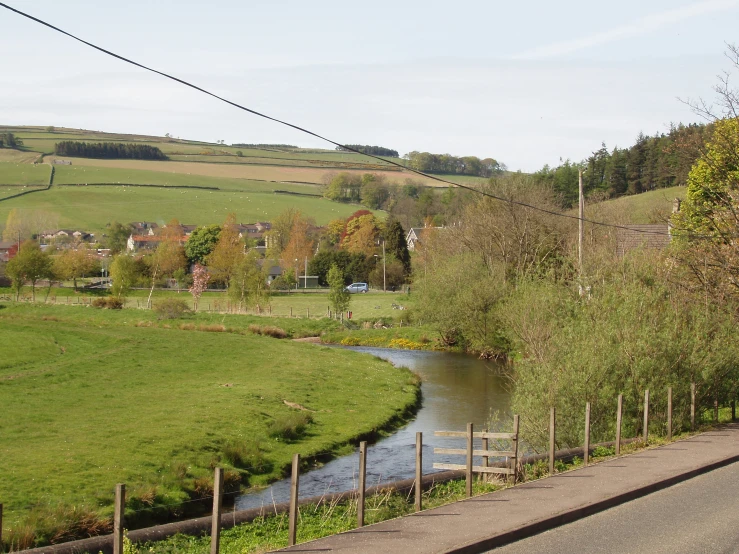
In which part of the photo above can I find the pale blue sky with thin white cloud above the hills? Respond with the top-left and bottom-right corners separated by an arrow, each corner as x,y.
0,0 -> 739,171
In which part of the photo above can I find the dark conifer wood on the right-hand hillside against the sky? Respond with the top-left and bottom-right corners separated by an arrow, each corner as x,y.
534,124 -> 711,207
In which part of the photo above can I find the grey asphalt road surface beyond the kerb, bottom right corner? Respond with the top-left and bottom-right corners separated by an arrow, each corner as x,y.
490,463 -> 739,554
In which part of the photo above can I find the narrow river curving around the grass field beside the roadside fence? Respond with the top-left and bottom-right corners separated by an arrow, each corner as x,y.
236,347 -> 510,510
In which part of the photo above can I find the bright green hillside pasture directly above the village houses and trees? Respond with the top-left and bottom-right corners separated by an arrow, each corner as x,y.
0,183 -> 368,232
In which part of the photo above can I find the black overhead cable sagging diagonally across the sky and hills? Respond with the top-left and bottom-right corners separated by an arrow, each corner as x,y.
0,2 -> 700,238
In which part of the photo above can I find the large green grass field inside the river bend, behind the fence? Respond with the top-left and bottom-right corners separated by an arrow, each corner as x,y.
0,304 -> 417,545
